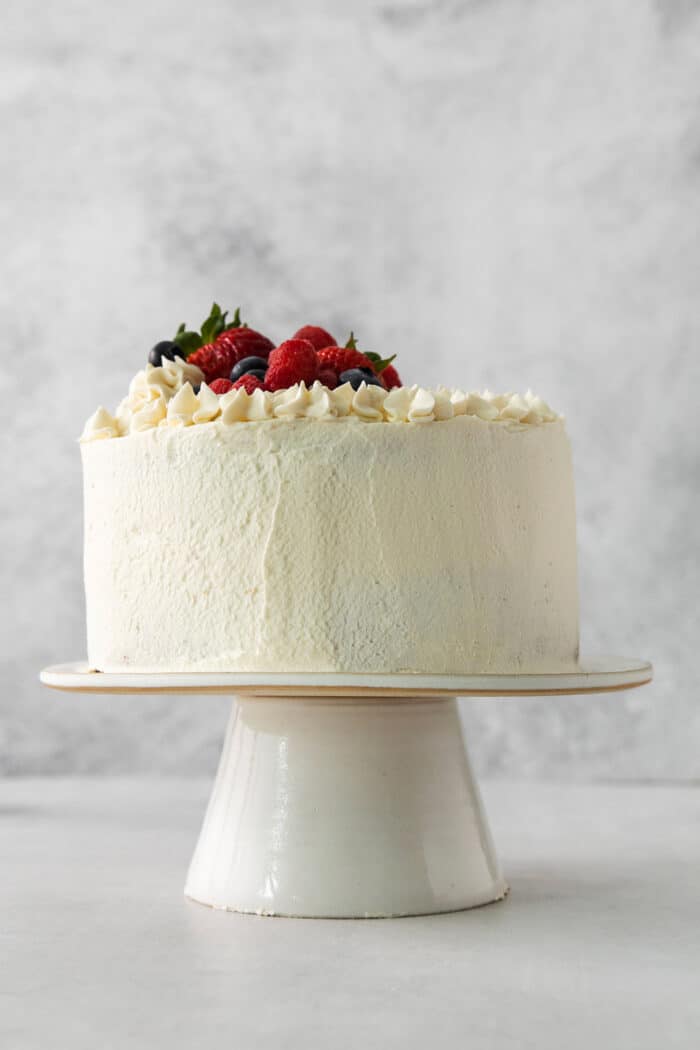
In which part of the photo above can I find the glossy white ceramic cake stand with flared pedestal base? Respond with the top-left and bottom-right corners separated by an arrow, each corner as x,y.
41,657 -> 652,918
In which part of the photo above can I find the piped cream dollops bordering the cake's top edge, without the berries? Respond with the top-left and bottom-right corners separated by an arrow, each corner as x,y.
81,367 -> 561,441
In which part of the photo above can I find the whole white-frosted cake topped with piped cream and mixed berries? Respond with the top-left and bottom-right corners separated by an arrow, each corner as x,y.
81,307 -> 578,674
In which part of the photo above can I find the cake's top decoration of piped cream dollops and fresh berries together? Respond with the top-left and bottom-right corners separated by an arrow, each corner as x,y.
81,303 -> 560,441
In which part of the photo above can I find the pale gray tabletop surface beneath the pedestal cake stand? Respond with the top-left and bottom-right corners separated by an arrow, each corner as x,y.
0,779 -> 700,1050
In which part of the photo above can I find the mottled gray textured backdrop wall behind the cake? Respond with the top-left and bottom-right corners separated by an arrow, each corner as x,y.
0,0 -> 700,778
